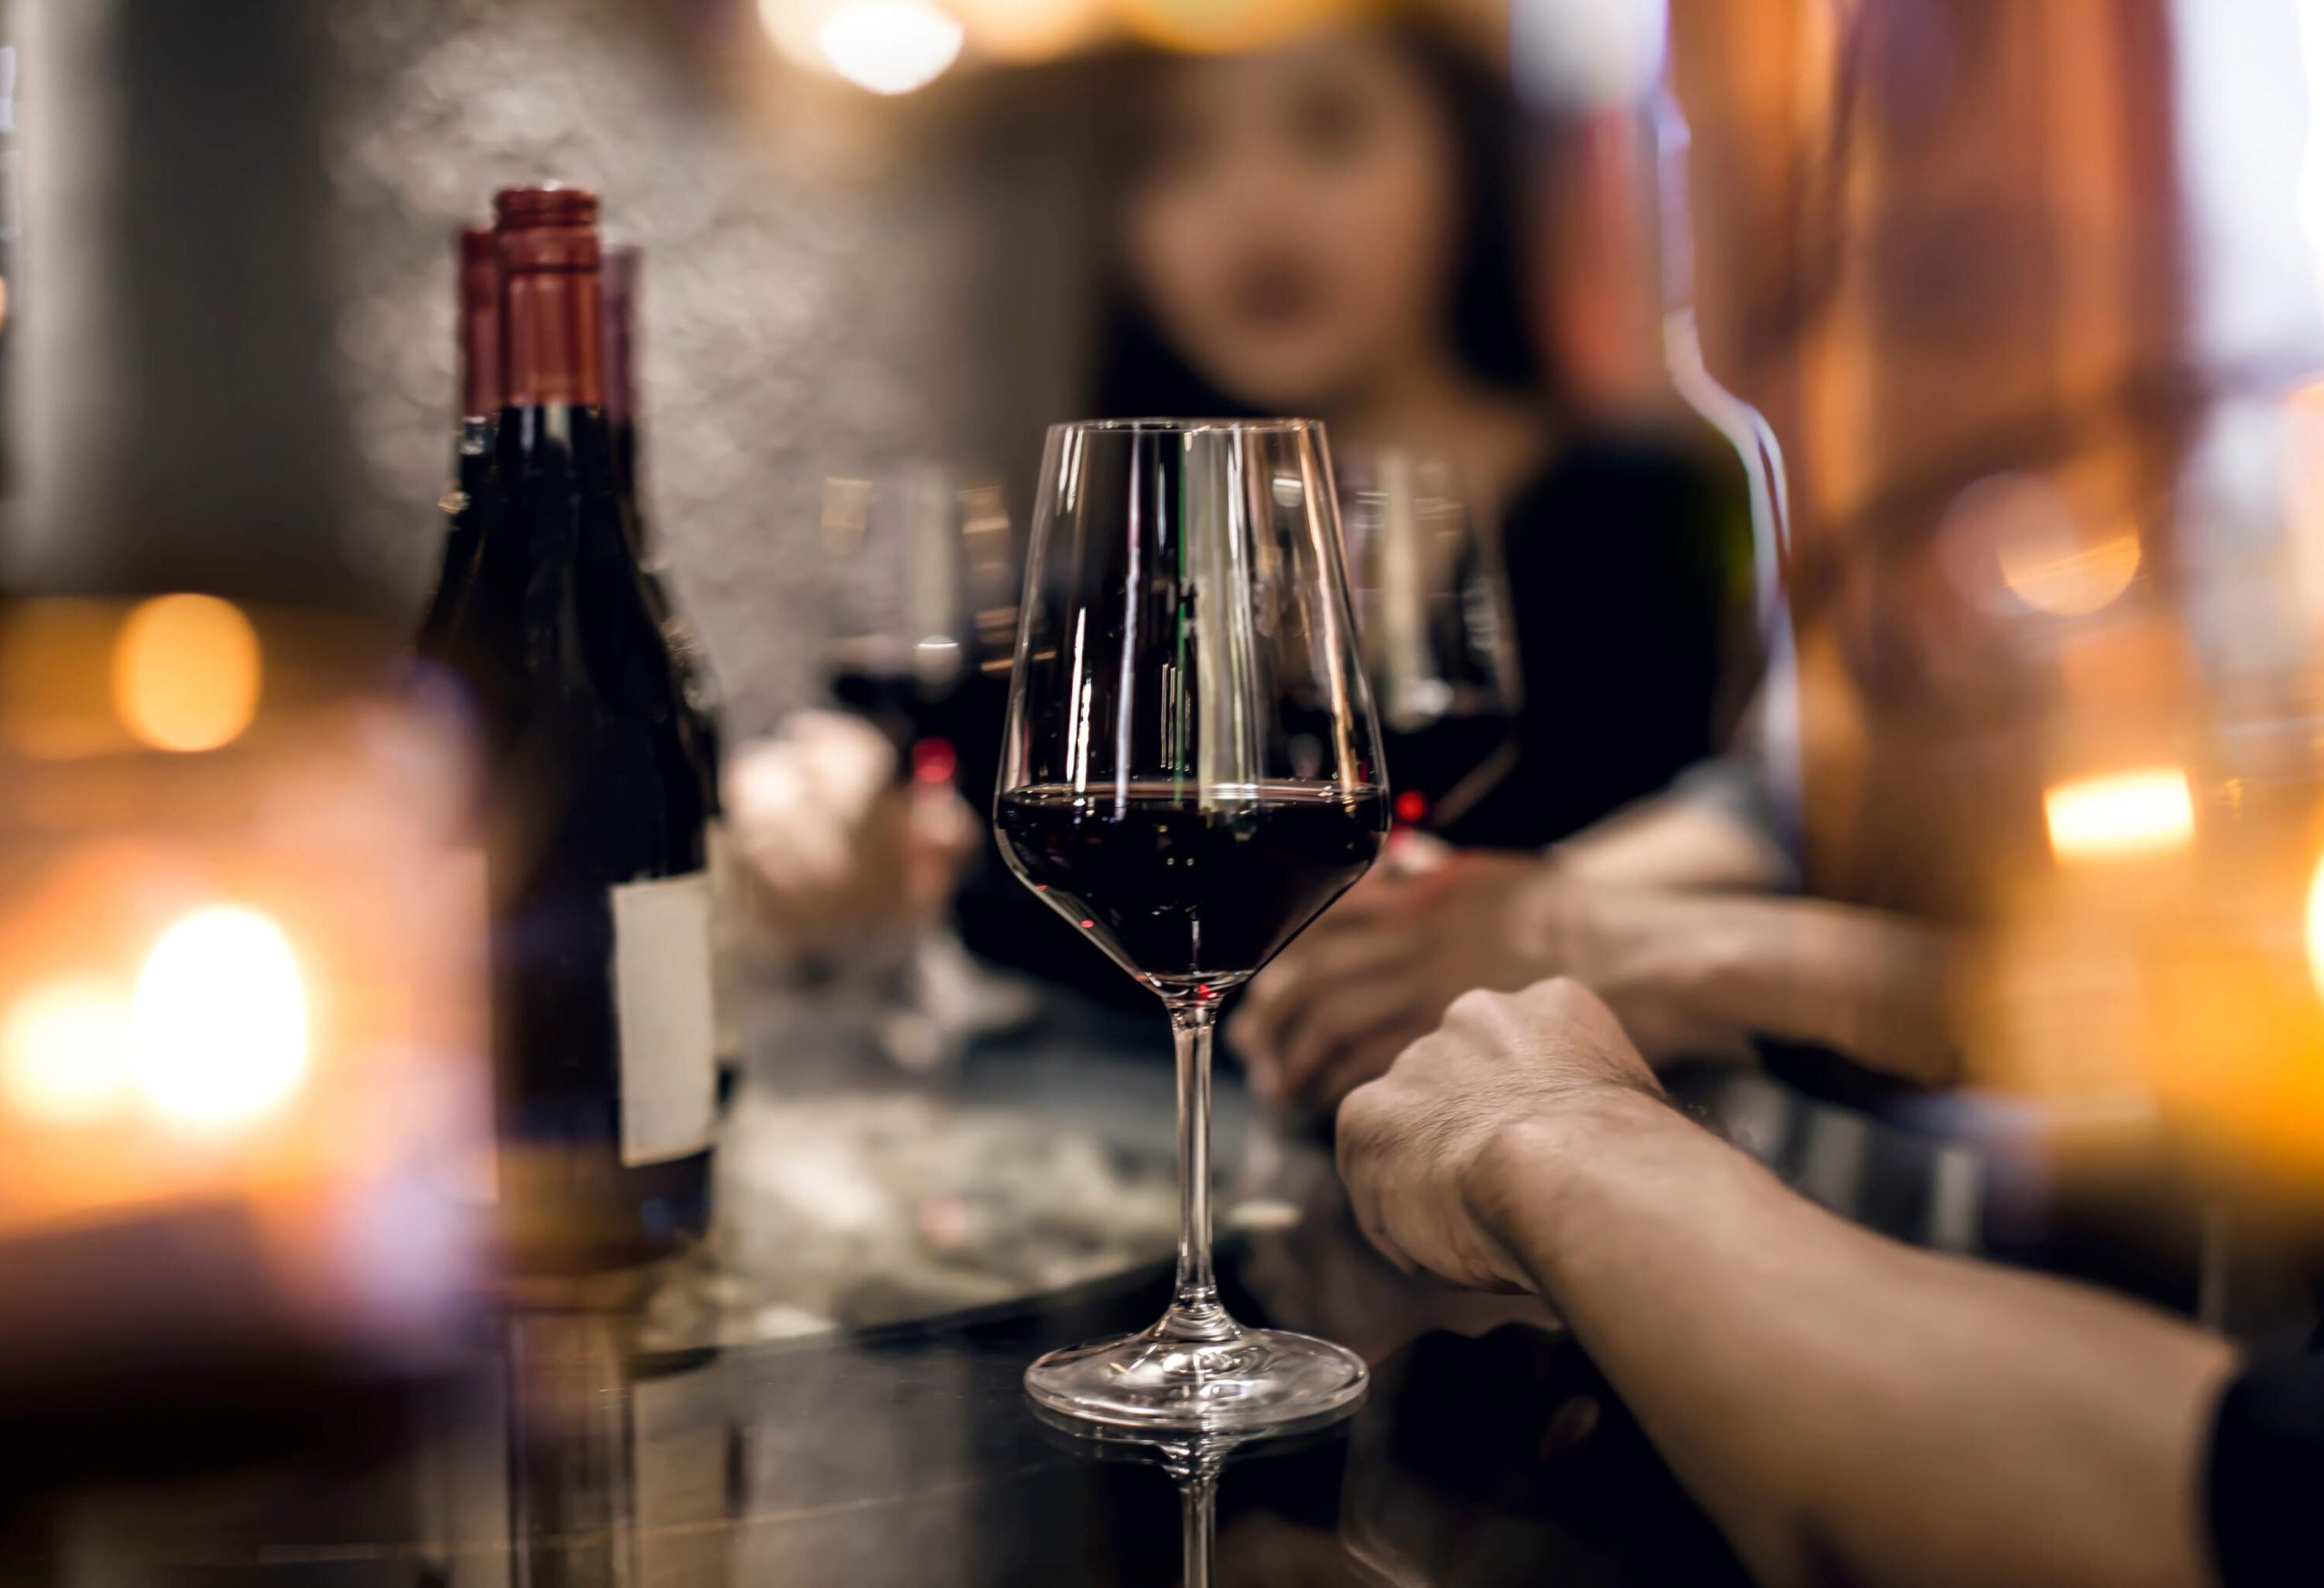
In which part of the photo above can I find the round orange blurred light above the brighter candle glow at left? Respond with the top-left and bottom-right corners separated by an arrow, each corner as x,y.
112,596 -> 262,751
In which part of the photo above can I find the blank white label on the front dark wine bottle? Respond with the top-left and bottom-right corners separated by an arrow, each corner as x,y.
614,872 -> 718,1165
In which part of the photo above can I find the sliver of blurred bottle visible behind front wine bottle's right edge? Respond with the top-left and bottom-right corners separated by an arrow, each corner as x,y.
602,244 -> 742,1074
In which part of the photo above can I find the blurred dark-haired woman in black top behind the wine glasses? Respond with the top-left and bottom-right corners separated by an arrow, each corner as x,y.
943,24 -> 1748,1000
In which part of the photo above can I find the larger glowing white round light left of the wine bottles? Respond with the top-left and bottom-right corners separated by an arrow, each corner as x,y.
130,904 -> 307,1128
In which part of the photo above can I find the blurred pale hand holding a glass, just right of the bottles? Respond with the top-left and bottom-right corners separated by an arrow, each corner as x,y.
725,712 -> 976,962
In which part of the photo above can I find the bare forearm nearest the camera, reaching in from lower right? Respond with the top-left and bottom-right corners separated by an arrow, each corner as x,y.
1476,1095 -> 2229,1588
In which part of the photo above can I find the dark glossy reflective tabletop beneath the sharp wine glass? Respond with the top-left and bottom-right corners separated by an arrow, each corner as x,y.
0,985 -> 2007,1588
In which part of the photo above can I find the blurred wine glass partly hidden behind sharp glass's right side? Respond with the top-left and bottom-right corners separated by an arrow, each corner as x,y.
1339,447 -> 1520,833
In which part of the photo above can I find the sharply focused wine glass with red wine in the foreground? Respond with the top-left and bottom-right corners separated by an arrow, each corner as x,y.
995,419 -> 1387,1430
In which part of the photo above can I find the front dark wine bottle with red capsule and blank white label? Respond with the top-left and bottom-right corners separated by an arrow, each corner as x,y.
451,186 -> 715,1272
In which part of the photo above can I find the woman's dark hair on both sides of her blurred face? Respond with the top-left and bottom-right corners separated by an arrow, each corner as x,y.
1090,21 -> 1552,419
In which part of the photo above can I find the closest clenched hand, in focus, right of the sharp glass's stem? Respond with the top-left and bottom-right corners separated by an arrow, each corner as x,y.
1339,979 -> 1661,1290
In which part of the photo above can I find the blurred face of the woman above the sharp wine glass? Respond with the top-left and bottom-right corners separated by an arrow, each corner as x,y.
1122,35 -> 1460,414
